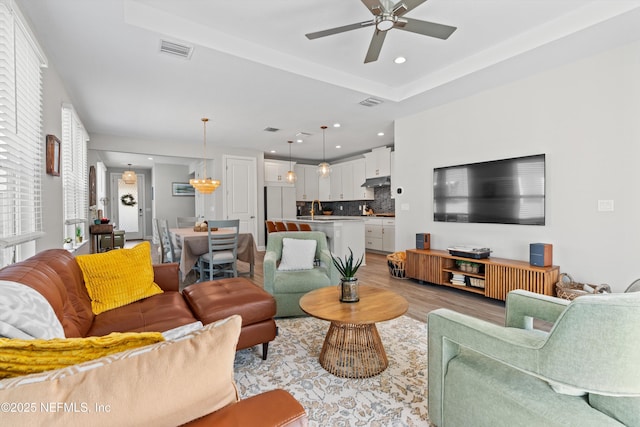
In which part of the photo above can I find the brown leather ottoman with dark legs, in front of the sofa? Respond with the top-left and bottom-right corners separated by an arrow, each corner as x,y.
182,277 -> 276,360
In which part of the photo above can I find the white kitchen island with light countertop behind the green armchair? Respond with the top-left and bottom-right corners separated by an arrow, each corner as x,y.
284,215 -> 366,264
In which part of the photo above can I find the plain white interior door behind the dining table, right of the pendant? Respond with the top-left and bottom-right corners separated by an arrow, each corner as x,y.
224,156 -> 258,237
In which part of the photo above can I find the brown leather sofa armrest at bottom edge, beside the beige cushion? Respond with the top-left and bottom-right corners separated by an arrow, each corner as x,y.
185,389 -> 309,427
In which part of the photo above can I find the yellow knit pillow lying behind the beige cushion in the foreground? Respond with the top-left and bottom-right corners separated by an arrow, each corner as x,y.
0,332 -> 164,378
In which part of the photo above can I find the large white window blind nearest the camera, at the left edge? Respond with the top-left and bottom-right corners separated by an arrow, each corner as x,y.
0,0 -> 46,266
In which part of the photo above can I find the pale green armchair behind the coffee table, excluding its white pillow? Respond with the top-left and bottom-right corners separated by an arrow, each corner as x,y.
263,231 -> 340,317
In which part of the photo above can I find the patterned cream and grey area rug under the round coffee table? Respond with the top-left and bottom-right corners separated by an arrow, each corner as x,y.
235,316 -> 429,427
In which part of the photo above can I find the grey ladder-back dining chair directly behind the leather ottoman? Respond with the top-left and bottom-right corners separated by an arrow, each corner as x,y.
198,219 -> 240,282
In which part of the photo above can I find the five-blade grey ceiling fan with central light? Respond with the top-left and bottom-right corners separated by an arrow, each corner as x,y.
306,0 -> 456,64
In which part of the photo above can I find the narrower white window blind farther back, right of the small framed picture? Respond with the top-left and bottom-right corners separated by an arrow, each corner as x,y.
61,104 -> 89,242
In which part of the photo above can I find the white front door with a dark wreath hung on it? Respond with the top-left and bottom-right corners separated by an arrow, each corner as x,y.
110,173 -> 144,240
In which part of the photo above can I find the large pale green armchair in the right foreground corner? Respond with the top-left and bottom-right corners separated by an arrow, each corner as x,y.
428,290 -> 640,427
